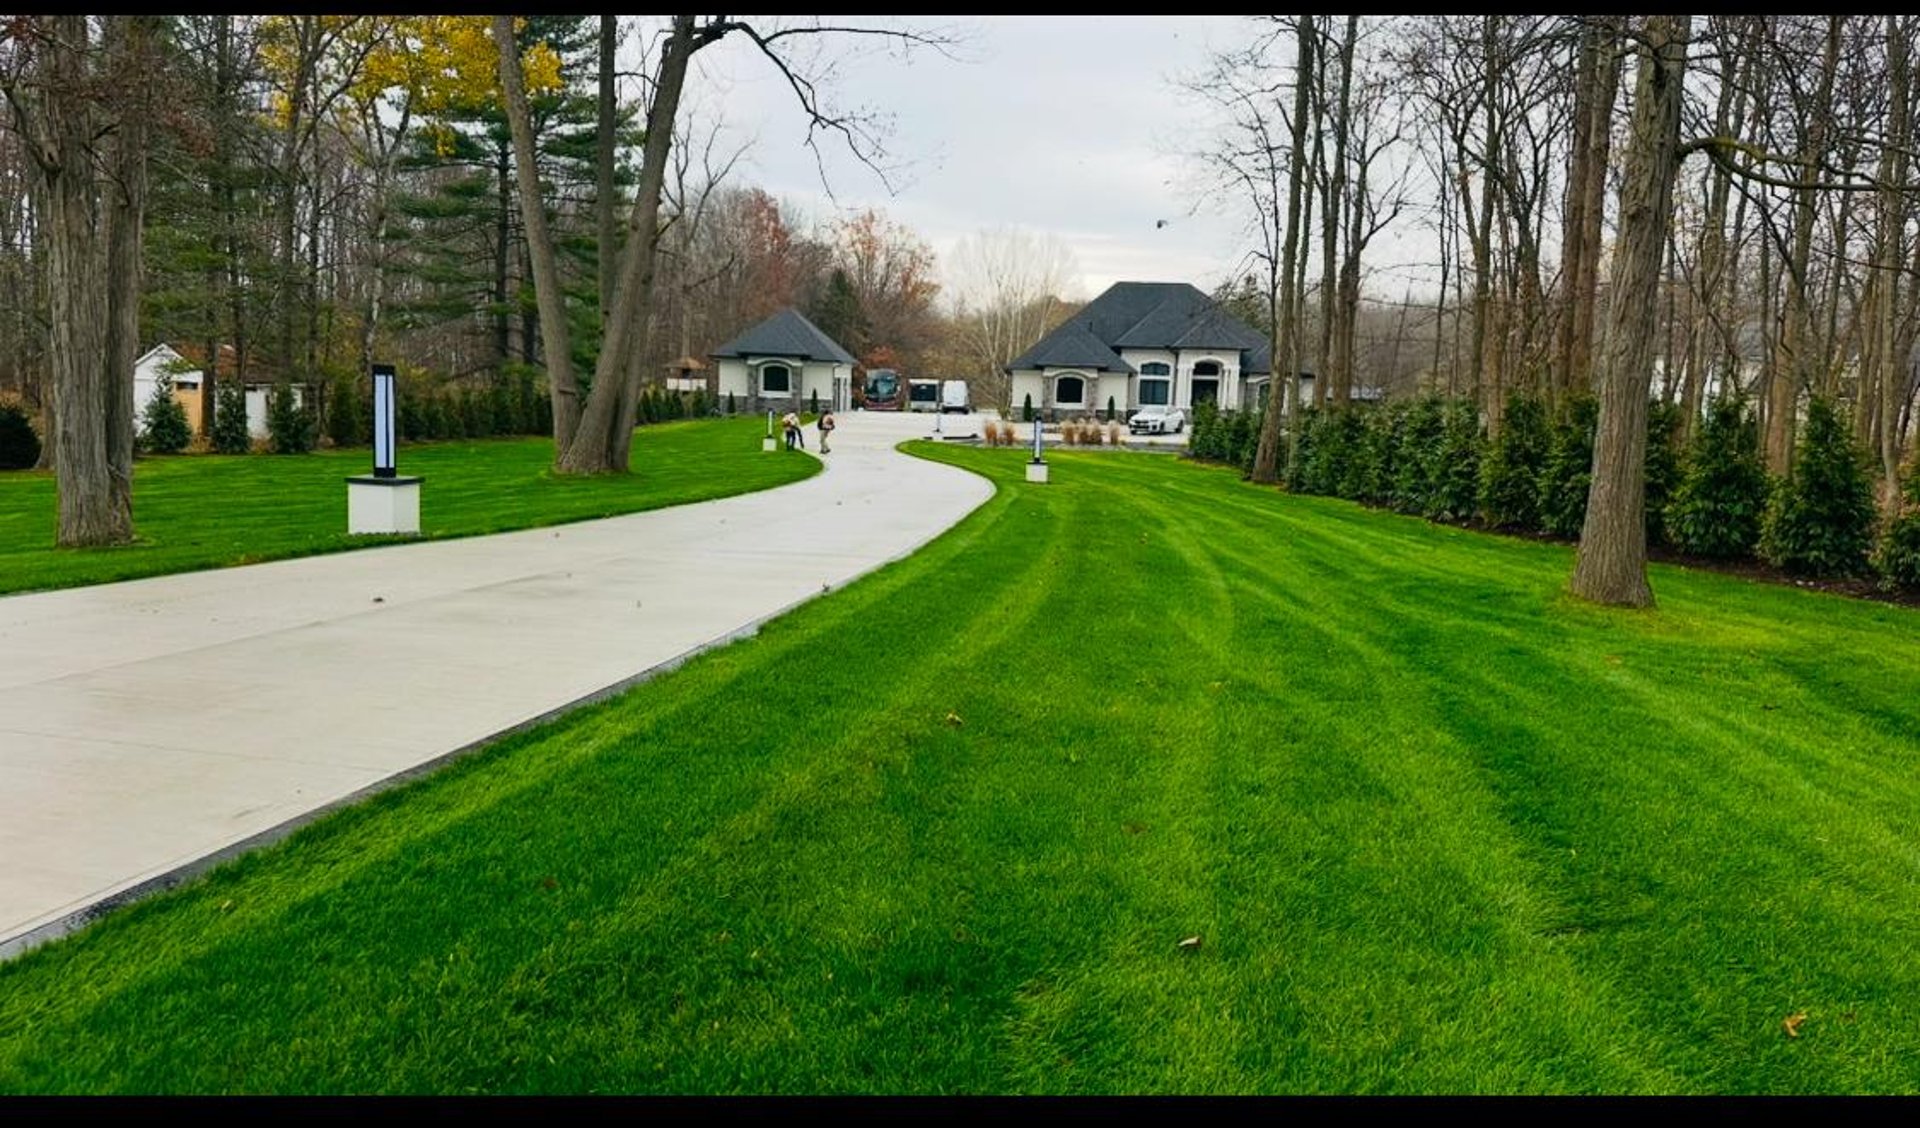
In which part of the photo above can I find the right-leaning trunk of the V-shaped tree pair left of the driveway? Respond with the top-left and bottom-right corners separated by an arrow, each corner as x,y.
559,15 -> 702,474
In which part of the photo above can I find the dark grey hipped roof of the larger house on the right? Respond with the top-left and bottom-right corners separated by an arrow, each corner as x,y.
1008,282 -> 1273,374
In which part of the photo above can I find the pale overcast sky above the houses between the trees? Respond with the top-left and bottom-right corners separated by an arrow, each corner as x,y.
668,15 -> 1436,312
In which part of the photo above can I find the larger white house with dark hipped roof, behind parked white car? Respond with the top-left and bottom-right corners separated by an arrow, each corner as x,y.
1006,282 -> 1273,418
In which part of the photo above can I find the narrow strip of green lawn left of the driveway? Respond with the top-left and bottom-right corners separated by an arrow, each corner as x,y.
0,416 -> 820,595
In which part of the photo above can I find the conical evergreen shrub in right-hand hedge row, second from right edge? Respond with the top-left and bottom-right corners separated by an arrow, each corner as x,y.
1761,397 -> 1874,577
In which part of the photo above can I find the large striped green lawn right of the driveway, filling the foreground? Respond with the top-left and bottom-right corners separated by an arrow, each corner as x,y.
0,445 -> 1920,1093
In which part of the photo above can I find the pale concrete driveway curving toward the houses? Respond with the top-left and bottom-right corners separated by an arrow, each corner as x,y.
0,412 -> 993,957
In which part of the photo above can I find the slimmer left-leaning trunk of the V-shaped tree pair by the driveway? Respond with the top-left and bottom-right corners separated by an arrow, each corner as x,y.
493,15 -> 580,456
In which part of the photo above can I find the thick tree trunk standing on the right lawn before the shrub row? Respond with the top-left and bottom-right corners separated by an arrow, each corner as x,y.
1571,15 -> 1690,606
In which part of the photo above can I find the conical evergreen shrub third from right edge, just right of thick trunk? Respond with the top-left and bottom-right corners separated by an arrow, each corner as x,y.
1667,397 -> 1768,560
